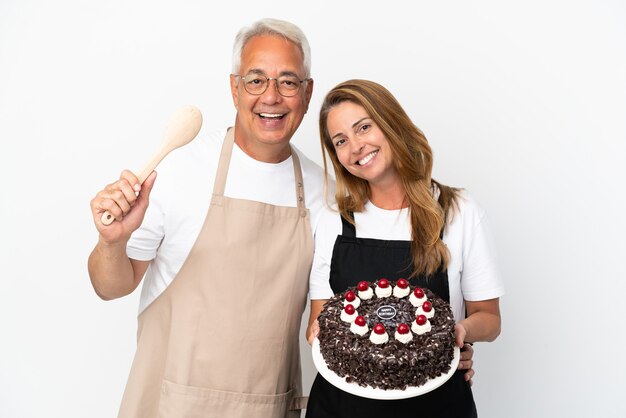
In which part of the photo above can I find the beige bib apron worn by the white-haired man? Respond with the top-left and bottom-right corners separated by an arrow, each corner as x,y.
119,129 -> 313,418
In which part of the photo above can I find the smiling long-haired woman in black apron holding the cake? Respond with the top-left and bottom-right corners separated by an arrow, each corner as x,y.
307,80 -> 504,418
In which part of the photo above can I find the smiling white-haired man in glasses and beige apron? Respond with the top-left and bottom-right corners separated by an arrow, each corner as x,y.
89,19 -> 324,418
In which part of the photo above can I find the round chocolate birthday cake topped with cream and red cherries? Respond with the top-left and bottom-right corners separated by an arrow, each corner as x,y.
318,279 -> 454,390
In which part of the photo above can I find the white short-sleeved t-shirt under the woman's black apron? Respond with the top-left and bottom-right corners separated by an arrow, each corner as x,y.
309,192 -> 504,321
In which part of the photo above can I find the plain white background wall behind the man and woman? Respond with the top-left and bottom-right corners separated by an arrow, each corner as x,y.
0,0 -> 626,418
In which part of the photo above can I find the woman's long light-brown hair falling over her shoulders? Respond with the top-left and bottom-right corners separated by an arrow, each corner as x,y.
319,80 -> 459,277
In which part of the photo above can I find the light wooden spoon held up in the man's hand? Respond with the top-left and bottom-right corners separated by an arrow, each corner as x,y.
100,106 -> 202,225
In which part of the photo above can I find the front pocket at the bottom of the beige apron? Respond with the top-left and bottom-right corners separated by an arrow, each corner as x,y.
159,380 -> 293,418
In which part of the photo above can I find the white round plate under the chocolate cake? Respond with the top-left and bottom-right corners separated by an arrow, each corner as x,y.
312,338 -> 461,400
